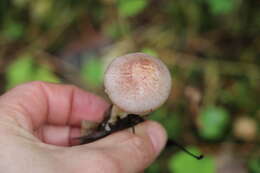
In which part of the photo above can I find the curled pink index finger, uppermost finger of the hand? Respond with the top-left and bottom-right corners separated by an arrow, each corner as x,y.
0,82 -> 108,130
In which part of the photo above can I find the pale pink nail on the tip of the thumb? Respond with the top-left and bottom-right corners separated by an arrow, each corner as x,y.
147,122 -> 167,153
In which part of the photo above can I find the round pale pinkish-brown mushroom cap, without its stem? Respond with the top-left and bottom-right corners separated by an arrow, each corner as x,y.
104,53 -> 171,115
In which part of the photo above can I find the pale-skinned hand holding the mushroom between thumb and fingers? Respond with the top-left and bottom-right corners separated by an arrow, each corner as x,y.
0,82 -> 166,173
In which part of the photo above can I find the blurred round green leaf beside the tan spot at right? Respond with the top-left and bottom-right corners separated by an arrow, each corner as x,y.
199,106 -> 230,140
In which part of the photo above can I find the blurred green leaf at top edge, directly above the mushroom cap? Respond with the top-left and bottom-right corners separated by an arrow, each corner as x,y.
118,0 -> 148,17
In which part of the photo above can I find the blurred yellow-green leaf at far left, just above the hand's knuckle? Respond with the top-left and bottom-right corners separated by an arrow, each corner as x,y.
6,55 -> 35,88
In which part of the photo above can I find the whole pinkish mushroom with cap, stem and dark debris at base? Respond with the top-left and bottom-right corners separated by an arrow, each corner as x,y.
81,53 -> 171,143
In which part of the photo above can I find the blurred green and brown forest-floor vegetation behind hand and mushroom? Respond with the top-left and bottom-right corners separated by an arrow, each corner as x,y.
0,0 -> 260,173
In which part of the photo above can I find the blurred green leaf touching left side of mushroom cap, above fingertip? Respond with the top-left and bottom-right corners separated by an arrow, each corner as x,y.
81,58 -> 103,87
